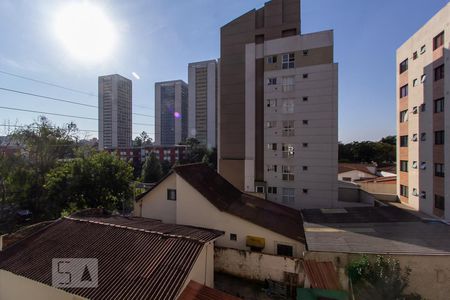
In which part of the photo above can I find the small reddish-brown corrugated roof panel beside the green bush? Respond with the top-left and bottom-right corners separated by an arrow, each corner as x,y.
303,260 -> 341,290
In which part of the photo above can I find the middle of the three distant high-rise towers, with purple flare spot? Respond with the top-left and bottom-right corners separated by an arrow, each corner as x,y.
155,80 -> 188,145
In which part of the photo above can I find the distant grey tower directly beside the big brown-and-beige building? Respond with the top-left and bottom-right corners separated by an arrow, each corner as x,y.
188,60 -> 217,148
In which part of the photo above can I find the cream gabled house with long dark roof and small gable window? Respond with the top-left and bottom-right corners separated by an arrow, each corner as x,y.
134,164 -> 305,257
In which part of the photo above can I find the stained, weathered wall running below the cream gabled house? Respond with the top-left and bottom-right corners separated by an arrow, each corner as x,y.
214,247 -> 305,284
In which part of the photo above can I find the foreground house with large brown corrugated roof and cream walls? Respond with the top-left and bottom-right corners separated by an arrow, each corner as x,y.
0,210 -> 223,300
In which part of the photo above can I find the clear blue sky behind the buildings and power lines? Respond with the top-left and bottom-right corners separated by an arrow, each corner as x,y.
0,0 -> 448,142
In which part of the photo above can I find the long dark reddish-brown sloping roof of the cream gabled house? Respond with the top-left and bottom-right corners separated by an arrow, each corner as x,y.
174,164 -> 305,242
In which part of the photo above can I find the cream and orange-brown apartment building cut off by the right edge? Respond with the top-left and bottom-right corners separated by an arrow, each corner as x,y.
397,4 -> 450,219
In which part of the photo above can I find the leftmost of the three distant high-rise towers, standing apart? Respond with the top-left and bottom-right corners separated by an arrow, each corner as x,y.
98,74 -> 133,150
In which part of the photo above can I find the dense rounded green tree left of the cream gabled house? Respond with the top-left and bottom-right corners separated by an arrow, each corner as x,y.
45,152 -> 133,217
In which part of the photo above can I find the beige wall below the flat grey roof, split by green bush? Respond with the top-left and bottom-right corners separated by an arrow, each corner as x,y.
305,252 -> 450,300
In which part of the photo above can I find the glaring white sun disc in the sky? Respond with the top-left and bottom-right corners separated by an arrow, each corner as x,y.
54,2 -> 116,63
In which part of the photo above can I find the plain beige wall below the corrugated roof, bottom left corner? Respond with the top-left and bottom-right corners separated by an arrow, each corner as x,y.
0,270 -> 86,300
